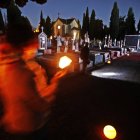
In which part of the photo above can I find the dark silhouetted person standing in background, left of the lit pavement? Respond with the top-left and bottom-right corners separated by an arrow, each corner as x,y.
80,42 -> 90,73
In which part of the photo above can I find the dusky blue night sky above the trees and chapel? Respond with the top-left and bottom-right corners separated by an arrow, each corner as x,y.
1,0 -> 140,27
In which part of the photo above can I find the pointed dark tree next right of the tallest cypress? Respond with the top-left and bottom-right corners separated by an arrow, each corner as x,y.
126,7 -> 136,35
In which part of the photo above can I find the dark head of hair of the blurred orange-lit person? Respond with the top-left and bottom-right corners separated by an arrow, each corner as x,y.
6,17 -> 34,48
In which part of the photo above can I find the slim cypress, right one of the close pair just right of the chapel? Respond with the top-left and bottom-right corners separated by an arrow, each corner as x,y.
89,9 -> 95,40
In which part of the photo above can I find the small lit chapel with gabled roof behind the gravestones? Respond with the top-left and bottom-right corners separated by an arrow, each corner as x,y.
53,18 -> 80,39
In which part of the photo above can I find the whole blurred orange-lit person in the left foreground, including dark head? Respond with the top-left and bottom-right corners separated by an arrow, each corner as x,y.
0,17 -> 65,140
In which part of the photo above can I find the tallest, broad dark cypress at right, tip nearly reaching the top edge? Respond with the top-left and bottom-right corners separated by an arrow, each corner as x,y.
110,2 -> 119,40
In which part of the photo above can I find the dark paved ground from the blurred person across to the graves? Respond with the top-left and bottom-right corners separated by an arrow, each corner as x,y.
2,52 -> 140,140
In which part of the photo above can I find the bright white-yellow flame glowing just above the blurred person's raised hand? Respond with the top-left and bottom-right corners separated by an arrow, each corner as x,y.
59,56 -> 72,69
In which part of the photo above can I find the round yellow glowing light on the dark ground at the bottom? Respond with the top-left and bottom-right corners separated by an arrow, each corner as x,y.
103,125 -> 117,139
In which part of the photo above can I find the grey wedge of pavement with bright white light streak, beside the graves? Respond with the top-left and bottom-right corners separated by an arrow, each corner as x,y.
91,53 -> 140,83
